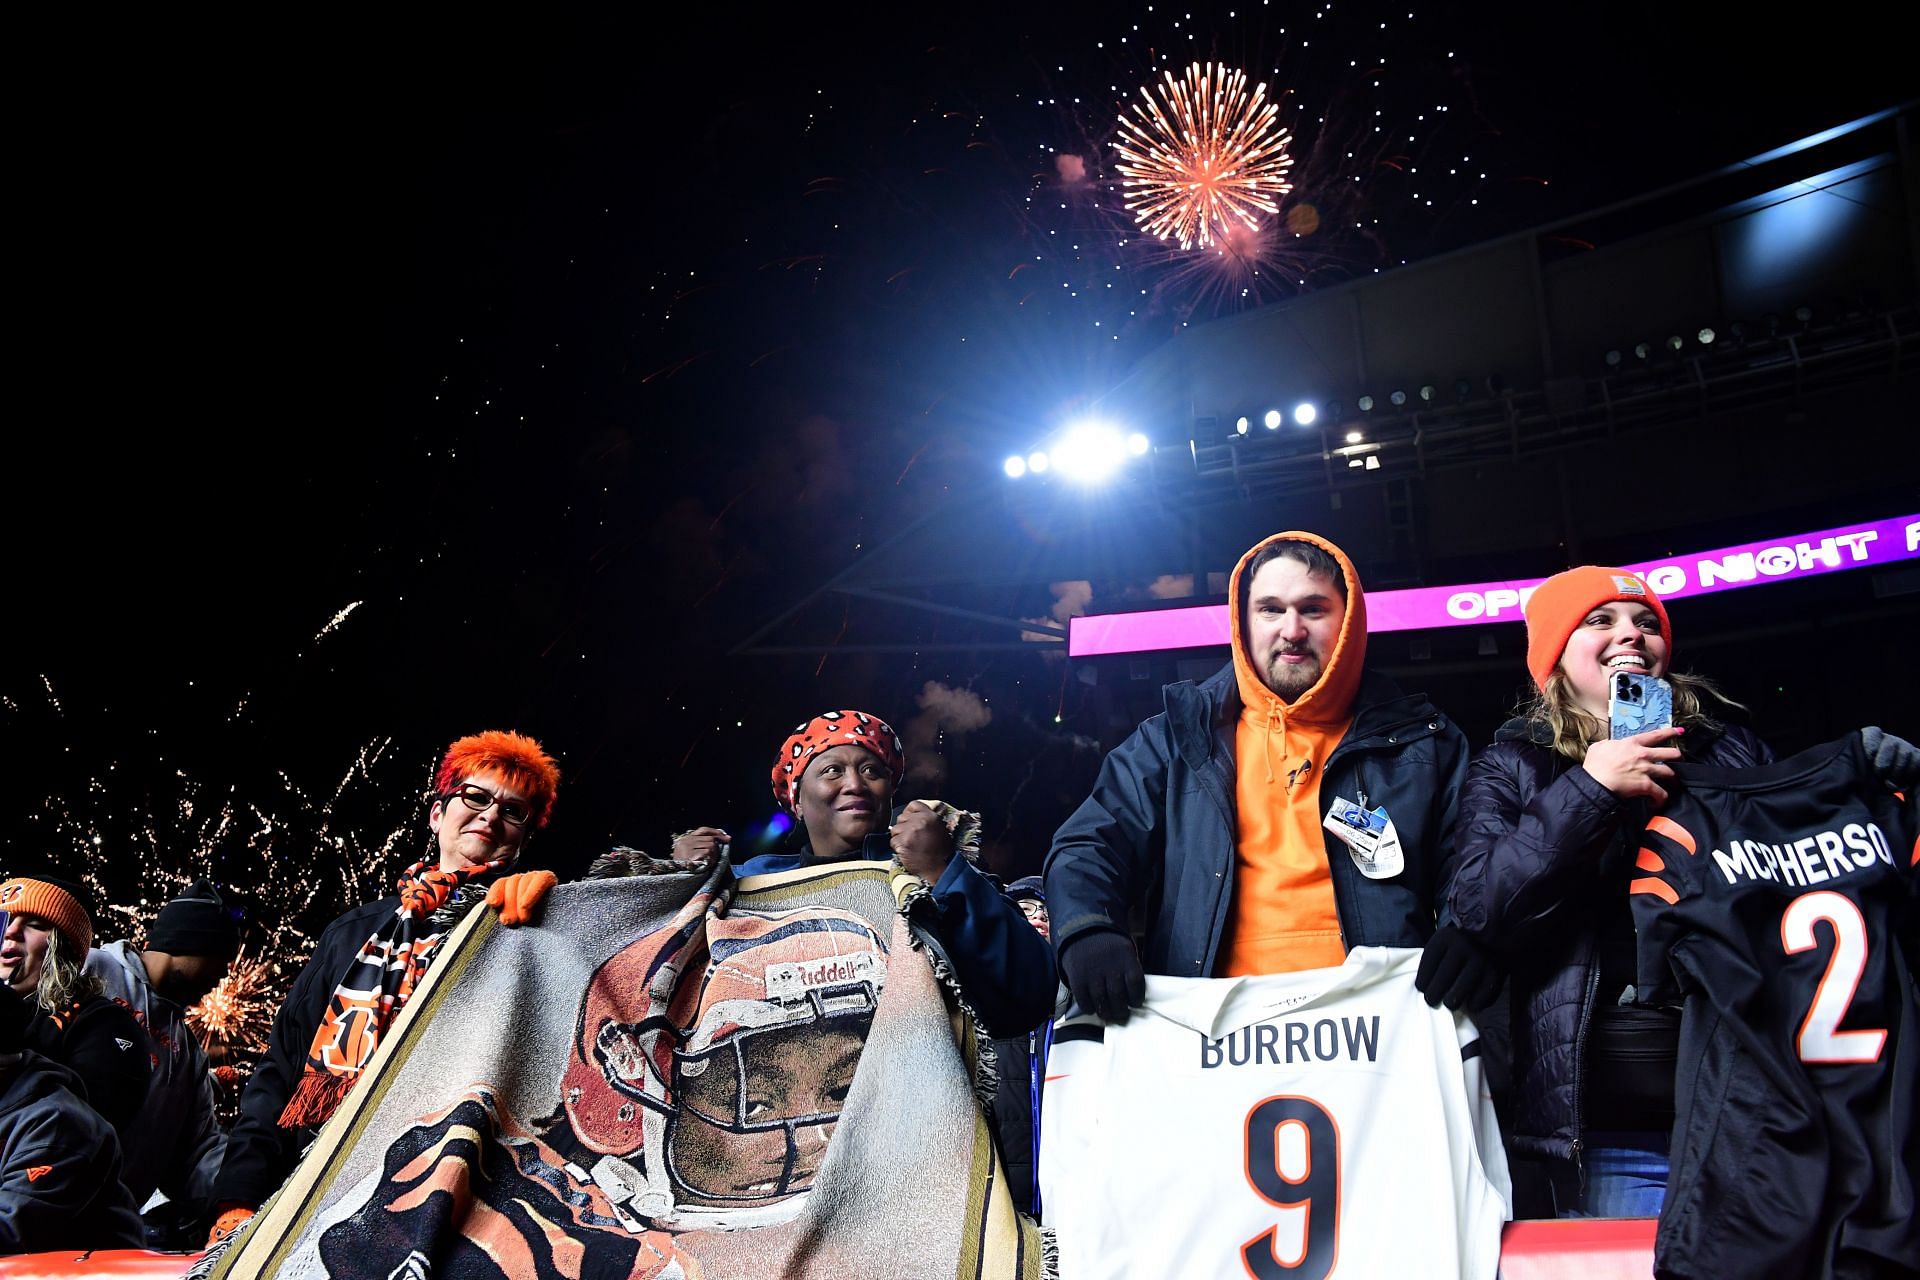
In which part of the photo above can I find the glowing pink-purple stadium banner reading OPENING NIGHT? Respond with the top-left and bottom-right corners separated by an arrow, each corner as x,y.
1068,514 -> 1920,658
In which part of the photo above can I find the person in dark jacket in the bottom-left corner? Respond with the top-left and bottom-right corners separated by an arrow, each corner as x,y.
0,986 -> 140,1253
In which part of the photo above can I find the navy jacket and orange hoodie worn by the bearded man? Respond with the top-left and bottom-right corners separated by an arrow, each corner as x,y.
1046,533 -> 1467,977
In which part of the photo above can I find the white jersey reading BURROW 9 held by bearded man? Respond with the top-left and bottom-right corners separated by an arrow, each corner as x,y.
1041,946 -> 1513,1280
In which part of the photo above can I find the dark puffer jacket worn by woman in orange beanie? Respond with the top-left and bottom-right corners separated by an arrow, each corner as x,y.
1444,720 -> 1772,1161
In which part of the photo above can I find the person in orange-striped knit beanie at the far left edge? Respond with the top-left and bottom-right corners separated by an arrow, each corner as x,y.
0,875 -> 154,1142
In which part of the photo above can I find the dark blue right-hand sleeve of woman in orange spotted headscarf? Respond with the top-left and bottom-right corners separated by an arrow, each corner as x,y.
927,854 -> 1060,1038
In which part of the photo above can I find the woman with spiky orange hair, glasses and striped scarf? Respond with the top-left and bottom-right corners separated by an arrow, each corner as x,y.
213,729 -> 561,1240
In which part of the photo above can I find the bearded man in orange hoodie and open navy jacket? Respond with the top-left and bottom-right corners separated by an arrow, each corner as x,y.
1046,532 -> 1500,1023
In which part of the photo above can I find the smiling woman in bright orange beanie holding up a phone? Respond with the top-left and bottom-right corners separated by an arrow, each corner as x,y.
1446,564 -> 1774,1217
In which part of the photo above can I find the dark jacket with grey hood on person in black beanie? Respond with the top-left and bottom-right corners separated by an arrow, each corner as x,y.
86,942 -> 227,1205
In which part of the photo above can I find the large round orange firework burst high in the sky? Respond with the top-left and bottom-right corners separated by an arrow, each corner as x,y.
1114,61 -> 1294,249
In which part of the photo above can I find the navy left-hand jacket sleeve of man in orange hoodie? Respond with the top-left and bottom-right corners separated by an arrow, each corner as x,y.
1046,716 -> 1173,948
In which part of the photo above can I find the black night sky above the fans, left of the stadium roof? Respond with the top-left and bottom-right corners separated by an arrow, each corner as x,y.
0,10 -> 1914,948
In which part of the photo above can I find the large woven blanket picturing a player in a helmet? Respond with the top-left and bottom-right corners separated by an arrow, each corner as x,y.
213,864 -> 1052,1280
